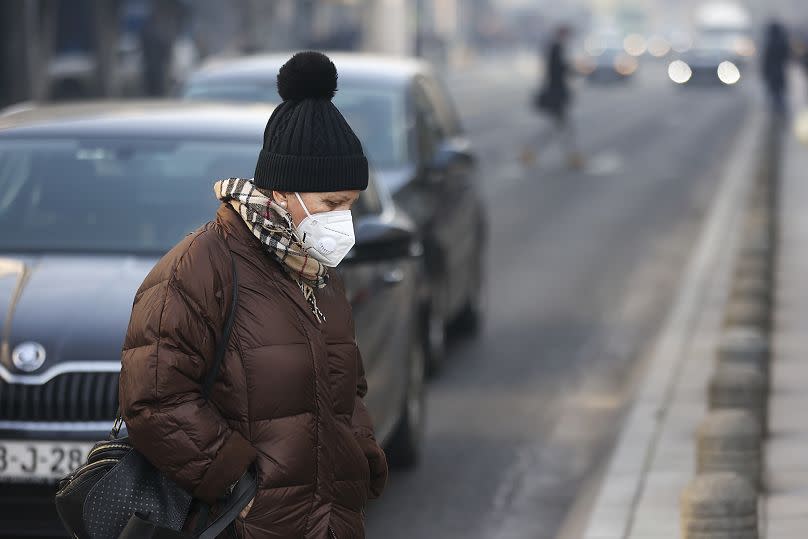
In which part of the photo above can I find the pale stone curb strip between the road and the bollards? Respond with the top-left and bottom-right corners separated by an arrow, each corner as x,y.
581,106 -> 768,539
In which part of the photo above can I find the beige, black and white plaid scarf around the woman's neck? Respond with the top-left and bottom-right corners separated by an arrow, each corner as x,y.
213,178 -> 328,322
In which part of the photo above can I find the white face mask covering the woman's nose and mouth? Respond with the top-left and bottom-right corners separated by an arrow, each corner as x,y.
295,193 -> 356,268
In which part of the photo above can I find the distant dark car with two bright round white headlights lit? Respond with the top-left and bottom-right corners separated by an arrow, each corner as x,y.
668,47 -> 746,87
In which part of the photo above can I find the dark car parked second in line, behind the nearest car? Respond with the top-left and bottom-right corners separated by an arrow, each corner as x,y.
181,54 -> 487,372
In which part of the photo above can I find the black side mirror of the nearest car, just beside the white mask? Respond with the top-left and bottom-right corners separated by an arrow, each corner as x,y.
345,215 -> 419,264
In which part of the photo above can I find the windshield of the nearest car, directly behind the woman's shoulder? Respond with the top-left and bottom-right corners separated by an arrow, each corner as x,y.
0,139 -> 259,253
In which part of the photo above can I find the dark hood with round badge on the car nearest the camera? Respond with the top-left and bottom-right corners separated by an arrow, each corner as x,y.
0,255 -> 157,374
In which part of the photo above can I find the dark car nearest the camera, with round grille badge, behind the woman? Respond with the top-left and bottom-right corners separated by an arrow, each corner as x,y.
0,102 -> 425,536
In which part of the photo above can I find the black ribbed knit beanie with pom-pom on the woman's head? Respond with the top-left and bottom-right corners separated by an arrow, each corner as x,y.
255,52 -> 368,193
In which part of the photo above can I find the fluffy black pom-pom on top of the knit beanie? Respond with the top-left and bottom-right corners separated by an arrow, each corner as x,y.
278,51 -> 337,101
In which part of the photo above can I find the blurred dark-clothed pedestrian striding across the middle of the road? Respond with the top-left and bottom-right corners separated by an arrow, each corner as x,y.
523,25 -> 583,169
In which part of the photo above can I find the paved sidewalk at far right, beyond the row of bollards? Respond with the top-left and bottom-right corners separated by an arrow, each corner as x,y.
764,121 -> 808,539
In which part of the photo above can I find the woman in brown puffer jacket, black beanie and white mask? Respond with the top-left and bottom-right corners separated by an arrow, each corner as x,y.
120,53 -> 387,539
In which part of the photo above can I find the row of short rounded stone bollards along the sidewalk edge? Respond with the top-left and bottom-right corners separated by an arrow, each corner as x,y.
682,117 -> 783,539
